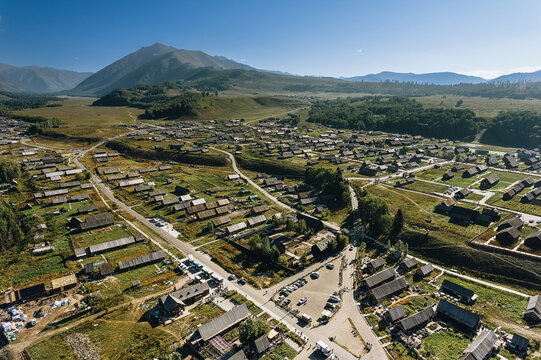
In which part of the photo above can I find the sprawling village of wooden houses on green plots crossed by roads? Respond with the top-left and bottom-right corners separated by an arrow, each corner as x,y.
0,114 -> 541,359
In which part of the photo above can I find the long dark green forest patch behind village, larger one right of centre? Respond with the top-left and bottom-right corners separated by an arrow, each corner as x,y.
308,97 -> 482,139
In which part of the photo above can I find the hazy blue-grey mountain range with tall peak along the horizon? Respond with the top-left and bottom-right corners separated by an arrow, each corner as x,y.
0,43 -> 541,96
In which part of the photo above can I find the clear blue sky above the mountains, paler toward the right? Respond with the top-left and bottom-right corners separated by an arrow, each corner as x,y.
0,0 -> 541,78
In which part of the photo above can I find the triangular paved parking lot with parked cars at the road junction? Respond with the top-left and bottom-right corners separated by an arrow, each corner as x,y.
276,258 -> 341,325
